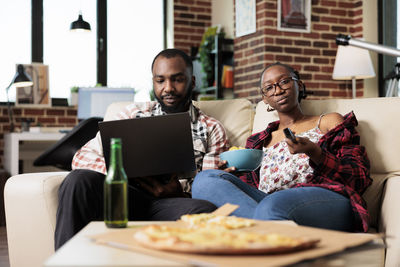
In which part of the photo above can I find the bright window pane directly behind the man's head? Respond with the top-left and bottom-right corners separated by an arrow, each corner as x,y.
107,0 -> 164,100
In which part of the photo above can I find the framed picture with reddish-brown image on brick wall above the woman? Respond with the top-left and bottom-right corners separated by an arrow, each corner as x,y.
277,0 -> 311,32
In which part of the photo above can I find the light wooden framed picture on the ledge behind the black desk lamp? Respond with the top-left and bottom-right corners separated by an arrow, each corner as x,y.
15,63 -> 51,106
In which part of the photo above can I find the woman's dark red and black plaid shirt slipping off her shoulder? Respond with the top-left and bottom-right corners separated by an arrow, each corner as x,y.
240,112 -> 372,232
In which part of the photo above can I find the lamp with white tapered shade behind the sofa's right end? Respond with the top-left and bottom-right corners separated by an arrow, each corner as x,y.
332,45 -> 375,98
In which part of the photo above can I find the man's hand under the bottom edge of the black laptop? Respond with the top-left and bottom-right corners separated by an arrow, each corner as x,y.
135,175 -> 185,198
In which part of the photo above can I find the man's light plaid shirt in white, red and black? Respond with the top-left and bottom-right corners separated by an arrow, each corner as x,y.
72,101 -> 229,192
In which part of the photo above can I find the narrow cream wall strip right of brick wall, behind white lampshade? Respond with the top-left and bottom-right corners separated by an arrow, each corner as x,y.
362,0 -> 379,97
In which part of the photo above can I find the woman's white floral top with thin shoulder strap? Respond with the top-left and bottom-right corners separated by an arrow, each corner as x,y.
258,122 -> 323,193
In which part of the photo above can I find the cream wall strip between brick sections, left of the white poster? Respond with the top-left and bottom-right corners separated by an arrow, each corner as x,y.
211,0 -> 234,38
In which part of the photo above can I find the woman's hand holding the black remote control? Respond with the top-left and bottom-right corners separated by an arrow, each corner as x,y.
285,137 -> 322,164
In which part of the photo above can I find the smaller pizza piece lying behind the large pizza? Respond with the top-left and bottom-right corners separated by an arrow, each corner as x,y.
181,213 -> 256,229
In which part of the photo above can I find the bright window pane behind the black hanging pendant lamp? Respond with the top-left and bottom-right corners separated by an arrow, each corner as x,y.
43,0 -> 96,97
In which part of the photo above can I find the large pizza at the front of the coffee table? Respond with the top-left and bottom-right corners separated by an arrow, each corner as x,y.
134,225 -> 319,255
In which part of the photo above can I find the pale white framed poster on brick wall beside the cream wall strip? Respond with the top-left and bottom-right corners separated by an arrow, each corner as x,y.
235,0 -> 256,37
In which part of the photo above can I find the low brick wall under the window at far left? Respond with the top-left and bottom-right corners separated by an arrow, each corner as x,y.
0,106 -> 78,167
